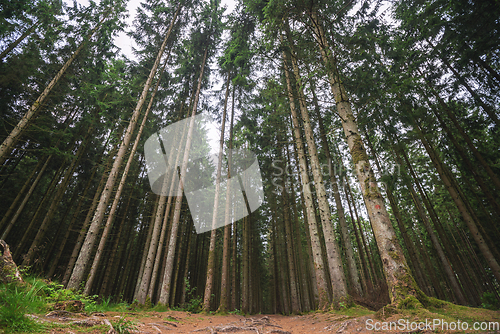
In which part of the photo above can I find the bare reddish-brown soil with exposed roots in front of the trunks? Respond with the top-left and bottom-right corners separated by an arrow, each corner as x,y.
27,309 -> 500,334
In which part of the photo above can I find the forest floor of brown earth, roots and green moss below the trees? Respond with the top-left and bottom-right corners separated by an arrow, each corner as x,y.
25,304 -> 500,334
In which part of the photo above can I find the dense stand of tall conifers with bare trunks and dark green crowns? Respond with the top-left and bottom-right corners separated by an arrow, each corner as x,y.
0,0 -> 500,320
